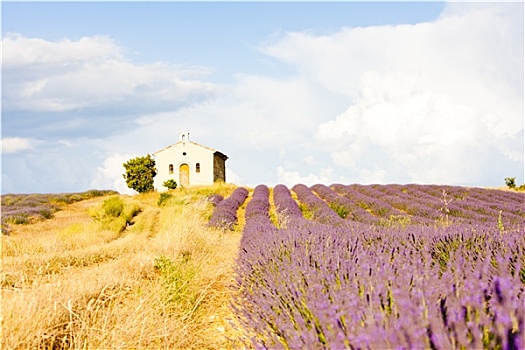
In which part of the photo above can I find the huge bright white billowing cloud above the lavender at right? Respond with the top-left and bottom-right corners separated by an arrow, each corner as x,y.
264,4 -> 524,184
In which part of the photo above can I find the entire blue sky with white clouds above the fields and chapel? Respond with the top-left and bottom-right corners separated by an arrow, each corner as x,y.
1,1 -> 524,194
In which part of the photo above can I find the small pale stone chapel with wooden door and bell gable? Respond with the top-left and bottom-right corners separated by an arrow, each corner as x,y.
153,132 -> 228,191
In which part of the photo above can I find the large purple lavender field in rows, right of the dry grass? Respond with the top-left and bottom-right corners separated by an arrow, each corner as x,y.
210,184 -> 525,349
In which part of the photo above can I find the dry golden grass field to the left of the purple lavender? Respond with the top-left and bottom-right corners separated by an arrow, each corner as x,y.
1,184 -> 248,349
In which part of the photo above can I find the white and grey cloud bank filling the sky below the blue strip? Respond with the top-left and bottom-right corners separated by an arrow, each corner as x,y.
2,3 -> 524,193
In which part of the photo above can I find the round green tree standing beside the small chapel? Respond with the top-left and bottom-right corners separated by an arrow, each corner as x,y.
123,154 -> 157,193
